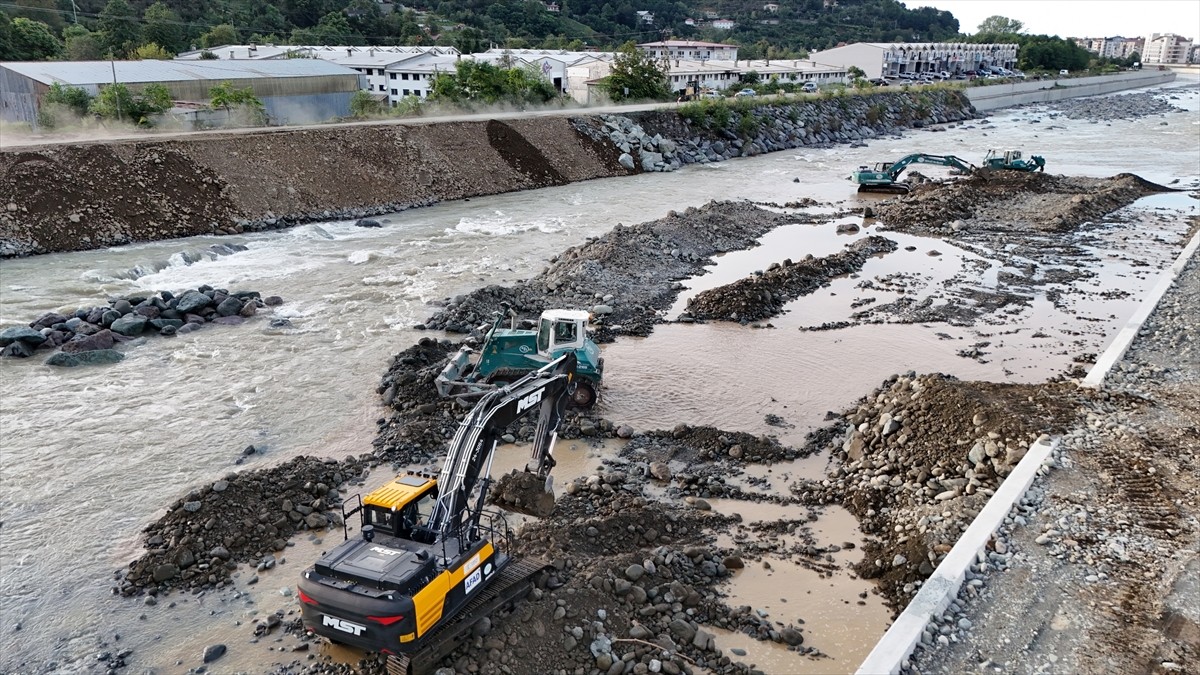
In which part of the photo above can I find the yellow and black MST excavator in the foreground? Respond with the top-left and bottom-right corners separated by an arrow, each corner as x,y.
298,352 -> 576,675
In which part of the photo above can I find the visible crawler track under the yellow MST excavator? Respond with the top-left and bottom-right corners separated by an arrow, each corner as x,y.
388,558 -> 550,675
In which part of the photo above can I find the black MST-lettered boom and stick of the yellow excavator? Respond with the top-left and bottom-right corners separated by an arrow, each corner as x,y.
427,353 -> 576,537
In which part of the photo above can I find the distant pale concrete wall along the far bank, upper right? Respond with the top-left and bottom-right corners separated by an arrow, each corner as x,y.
966,71 -> 1176,112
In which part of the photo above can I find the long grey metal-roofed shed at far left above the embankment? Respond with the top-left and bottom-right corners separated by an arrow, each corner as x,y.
0,59 -> 366,124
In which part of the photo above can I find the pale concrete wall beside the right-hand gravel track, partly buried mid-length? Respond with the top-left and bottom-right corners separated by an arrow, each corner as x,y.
856,228 -> 1200,675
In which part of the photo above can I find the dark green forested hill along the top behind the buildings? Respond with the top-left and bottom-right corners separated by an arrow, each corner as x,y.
0,0 -> 959,60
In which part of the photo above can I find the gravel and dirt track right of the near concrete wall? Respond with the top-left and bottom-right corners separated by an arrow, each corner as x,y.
907,247 -> 1200,674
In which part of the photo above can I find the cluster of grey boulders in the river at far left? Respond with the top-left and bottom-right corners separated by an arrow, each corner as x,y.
0,286 -> 283,366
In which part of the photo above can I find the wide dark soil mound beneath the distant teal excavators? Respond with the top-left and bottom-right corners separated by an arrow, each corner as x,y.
875,171 -> 1171,238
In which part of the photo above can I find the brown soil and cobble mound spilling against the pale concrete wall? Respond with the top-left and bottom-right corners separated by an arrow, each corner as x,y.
792,374 -> 1086,611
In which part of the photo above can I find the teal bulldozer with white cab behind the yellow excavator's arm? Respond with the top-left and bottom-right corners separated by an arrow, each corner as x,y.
434,310 -> 604,410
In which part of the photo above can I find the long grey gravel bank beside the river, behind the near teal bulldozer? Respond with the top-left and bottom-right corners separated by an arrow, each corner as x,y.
419,202 -> 808,342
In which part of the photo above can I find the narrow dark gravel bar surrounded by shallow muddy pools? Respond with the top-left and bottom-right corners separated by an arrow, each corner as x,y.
686,235 -> 899,323
